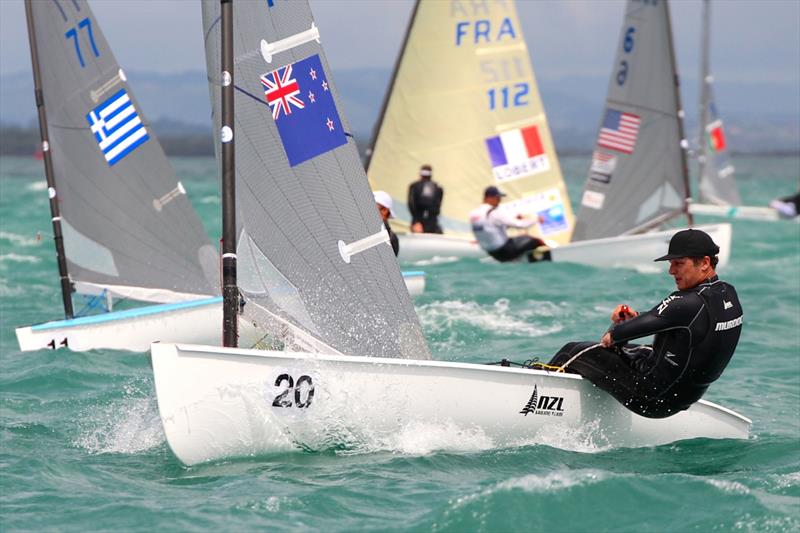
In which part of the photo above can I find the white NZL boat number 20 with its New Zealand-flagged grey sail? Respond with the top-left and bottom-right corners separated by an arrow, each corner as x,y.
152,0 -> 750,465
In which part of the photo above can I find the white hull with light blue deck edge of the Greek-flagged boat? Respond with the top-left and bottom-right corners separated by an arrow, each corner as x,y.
16,271 -> 425,352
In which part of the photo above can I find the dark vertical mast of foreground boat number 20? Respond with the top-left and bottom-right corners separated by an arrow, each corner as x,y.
220,0 -> 239,348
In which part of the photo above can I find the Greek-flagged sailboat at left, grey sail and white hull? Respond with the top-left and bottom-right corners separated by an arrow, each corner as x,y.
17,0 -> 219,351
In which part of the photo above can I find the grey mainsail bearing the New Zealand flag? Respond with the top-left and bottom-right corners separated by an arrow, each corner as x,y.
202,0 -> 429,358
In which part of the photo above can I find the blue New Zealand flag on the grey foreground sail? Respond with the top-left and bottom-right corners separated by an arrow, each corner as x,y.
261,55 -> 347,167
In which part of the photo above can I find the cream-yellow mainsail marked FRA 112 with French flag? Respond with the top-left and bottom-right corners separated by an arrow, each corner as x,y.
367,0 -> 573,244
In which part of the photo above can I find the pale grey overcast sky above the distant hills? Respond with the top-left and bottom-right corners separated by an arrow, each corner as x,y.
0,0 -> 800,84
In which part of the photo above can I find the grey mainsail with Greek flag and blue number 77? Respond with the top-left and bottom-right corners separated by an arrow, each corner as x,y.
29,0 -> 218,302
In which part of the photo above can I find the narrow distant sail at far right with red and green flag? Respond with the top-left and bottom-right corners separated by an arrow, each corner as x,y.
697,0 -> 741,205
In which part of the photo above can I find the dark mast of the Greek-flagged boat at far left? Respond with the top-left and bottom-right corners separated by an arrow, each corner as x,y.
25,0 -> 73,318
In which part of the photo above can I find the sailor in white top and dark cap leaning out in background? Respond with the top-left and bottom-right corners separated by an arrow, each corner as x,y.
469,185 -> 550,263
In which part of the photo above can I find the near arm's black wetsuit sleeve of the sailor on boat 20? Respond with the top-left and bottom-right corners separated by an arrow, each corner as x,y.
610,291 -> 703,344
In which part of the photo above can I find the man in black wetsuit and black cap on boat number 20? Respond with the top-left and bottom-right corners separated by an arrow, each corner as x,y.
549,229 -> 742,418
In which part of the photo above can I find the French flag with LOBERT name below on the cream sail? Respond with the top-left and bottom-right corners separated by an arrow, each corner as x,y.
486,126 -> 550,182
